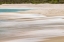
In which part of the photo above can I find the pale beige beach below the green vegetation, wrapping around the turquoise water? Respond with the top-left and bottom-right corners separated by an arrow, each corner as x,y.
0,4 -> 64,16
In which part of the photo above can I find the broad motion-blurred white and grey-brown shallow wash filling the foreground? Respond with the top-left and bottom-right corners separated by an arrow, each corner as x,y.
0,14 -> 64,42
